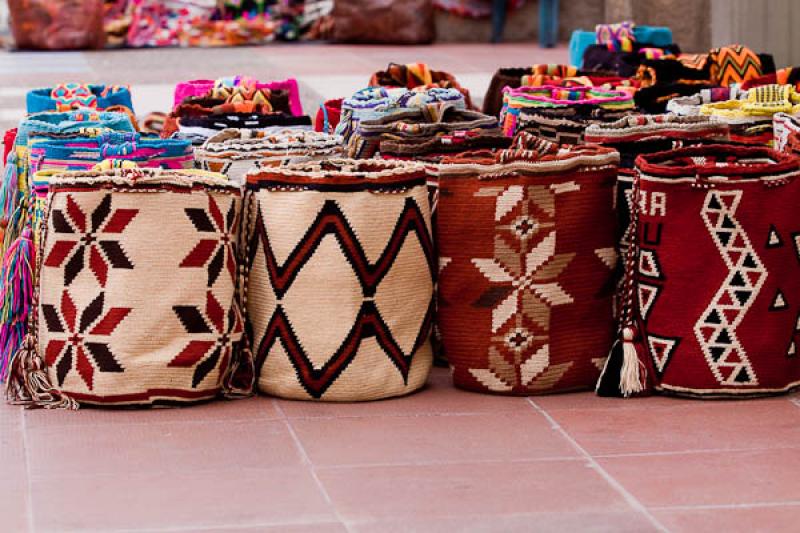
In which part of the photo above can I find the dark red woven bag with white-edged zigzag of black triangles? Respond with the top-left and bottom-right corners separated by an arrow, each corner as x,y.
598,144 -> 800,397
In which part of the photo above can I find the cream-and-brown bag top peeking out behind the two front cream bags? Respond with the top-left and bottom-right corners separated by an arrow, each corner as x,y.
195,129 -> 342,184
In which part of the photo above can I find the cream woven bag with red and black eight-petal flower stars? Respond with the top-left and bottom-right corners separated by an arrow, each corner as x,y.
4,169 -> 252,408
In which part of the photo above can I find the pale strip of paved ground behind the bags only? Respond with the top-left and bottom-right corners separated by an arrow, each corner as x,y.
0,44 -> 568,128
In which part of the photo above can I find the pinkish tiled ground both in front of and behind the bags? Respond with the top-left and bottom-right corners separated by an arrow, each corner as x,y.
0,45 -> 800,533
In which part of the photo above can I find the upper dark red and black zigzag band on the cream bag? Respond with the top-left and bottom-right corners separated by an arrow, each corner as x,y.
250,198 -> 436,298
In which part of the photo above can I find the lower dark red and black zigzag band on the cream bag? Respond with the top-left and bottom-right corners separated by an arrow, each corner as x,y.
256,299 -> 433,399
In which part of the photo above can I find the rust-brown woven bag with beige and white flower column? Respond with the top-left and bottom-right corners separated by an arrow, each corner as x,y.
436,132 -> 619,395
